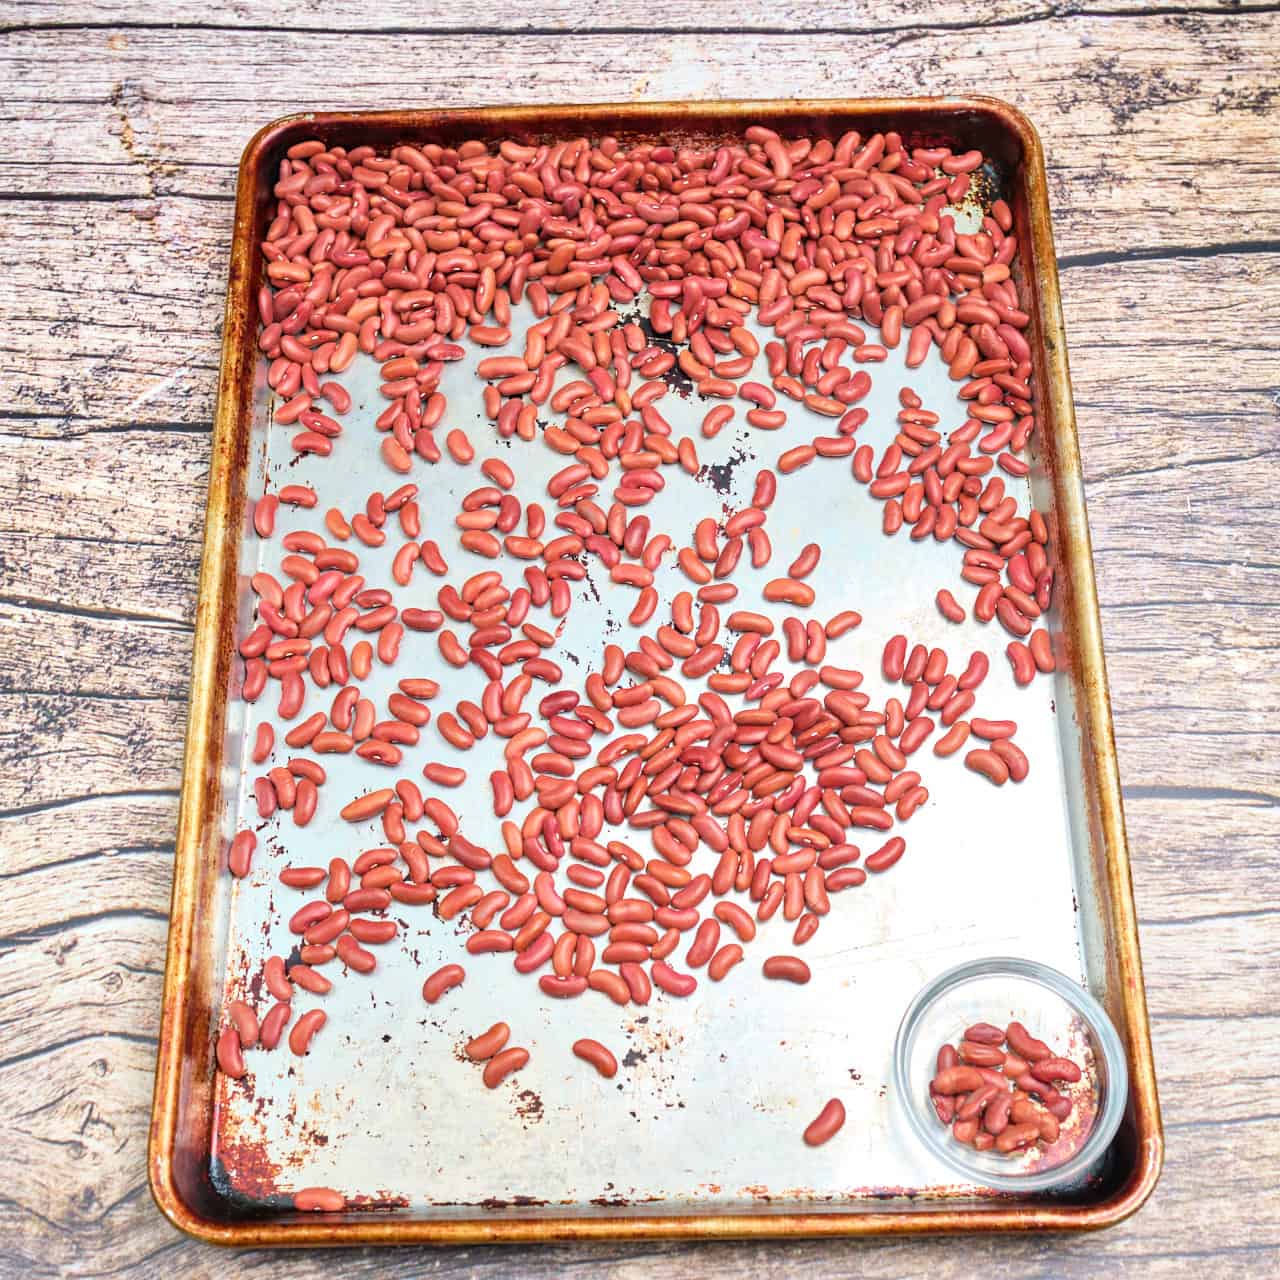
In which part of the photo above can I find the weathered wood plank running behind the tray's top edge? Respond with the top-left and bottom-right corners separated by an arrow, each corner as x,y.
0,15 -> 1277,262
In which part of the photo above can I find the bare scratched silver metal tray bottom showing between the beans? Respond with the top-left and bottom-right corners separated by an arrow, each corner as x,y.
211,202 -> 1105,1216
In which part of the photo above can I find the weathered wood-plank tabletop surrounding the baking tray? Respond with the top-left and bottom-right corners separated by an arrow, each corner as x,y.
0,0 -> 1280,1277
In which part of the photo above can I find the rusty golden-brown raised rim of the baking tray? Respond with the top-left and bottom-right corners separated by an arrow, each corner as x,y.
148,96 -> 1164,1247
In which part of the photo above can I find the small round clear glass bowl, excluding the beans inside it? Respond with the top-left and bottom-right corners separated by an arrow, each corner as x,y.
893,956 -> 1129,1192
